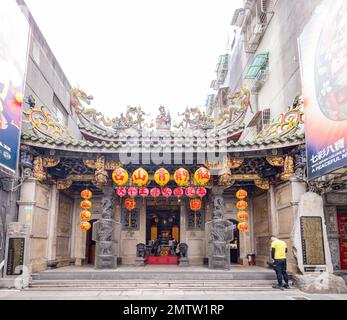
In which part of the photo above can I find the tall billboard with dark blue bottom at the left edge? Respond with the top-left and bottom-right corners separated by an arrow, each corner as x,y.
0,0 -> 29,173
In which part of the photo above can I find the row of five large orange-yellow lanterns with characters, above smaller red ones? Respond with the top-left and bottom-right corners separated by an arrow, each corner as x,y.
112,167 -> 211,188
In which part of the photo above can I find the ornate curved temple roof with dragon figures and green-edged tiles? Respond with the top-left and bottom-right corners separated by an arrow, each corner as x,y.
22,88 -> 305,154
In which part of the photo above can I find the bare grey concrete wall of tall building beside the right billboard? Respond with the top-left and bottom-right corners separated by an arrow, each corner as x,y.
255,0 -> 321,116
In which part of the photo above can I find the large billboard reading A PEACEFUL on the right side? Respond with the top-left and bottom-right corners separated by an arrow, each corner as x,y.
299,0 -> 347,180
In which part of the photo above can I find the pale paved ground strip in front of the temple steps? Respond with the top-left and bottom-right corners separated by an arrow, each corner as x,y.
0,289 -> 347,300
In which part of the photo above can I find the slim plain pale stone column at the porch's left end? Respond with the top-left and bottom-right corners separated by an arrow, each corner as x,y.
47,185 -> 59,269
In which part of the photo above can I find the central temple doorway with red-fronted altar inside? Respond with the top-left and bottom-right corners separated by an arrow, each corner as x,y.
146,206 -> 180,264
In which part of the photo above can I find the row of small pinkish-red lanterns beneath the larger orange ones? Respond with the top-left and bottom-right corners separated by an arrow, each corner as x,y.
116,187 -> 207,199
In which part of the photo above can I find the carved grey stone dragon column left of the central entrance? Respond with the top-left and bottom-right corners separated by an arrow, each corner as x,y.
93,187 -> 120,269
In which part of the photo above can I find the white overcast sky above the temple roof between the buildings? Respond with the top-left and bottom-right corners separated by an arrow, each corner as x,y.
26,0 -> 242,120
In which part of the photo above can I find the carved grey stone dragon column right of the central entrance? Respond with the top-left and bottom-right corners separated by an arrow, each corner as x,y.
206,187 -> 233,269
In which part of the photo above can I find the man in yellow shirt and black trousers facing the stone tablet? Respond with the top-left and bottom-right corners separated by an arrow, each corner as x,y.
271,236 -> 289,290
